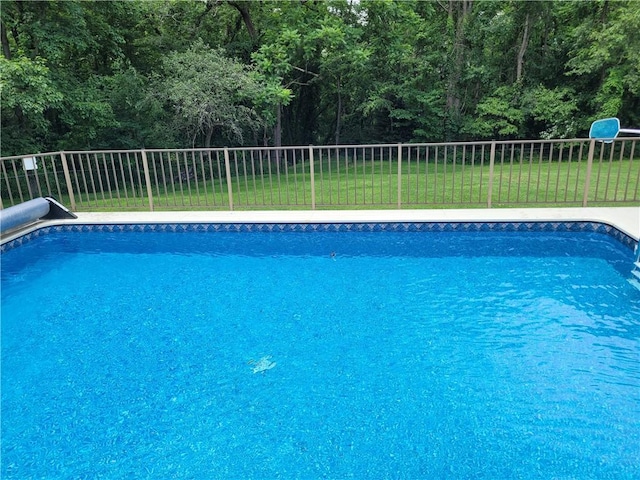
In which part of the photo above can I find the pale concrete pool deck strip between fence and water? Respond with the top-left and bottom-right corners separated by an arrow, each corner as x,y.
2,207 -> 640,243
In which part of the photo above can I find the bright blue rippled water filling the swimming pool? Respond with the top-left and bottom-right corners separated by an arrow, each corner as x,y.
0,226 -> 640,479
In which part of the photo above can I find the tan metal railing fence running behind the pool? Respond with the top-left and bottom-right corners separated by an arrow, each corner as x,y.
0,138 -> 640,211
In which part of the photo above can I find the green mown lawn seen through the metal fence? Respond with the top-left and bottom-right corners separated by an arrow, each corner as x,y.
4,158 -> 640,211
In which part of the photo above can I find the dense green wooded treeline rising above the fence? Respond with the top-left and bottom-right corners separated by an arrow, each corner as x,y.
0,0 -> 640,156
